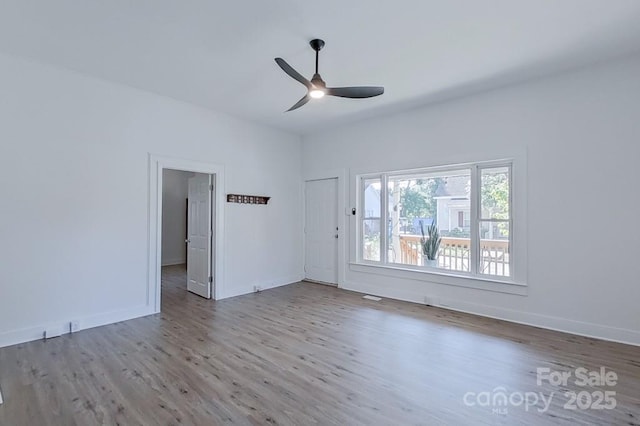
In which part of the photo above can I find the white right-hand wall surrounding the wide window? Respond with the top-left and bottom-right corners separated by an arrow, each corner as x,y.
303,56 -> 640,344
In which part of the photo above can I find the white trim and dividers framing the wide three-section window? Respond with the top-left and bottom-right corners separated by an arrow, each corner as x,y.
349,153 -> 528,295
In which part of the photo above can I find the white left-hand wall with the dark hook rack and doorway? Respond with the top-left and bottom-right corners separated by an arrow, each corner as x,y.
0,55 -> 302,346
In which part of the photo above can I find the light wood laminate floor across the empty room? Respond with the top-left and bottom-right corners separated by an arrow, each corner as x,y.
0,266 -> 640,426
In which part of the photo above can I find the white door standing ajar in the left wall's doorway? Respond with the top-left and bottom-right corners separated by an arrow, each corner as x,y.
186,174 -> 213,299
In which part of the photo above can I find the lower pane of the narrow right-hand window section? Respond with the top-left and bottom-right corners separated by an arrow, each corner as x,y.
478,221 -> 511,277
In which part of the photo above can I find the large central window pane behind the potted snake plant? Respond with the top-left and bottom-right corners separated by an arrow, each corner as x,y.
388,169 -> 471,271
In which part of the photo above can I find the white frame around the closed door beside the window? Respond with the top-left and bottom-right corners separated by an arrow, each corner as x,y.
301,169 -> 350,288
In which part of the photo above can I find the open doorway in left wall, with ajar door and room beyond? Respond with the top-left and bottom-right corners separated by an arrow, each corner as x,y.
161,169 -> 215,299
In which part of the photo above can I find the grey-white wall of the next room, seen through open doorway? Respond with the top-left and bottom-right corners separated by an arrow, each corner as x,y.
162,169 -> 195,266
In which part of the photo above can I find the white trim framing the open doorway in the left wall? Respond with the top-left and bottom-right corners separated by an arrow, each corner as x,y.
147,154 -> 225,313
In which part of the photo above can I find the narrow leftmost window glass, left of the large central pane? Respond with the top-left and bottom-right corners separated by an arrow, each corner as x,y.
361,178 -> 381,261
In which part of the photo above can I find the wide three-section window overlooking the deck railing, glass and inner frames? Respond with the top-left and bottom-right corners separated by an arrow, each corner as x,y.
357,161 -> 513,281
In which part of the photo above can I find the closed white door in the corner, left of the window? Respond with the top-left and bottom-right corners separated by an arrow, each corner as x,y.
304,179 -> 339,284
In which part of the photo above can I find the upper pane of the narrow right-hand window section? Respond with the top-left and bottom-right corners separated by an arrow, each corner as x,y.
480,167 -> 510,219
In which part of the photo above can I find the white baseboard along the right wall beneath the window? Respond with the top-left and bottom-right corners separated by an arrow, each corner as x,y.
340,282 -> 640,346
